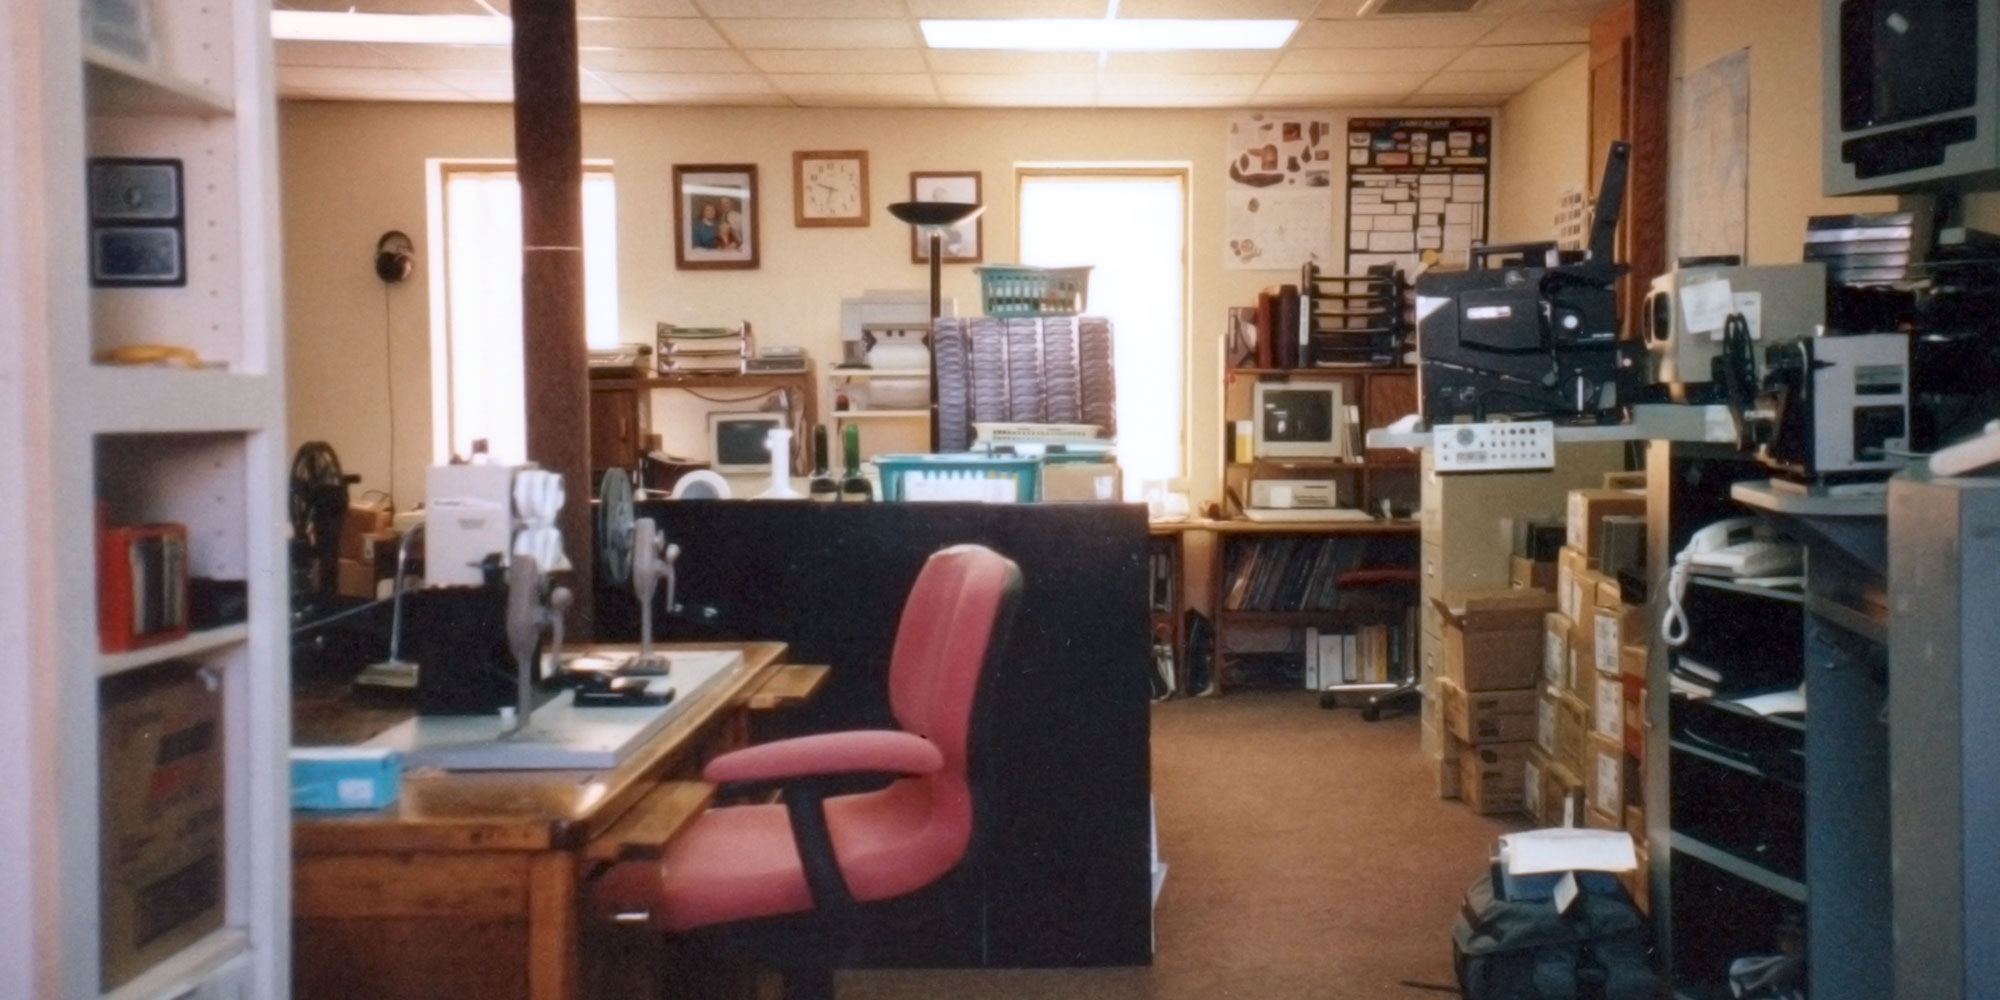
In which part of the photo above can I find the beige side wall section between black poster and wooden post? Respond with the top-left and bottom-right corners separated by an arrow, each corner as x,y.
1488,54 -> 1590,244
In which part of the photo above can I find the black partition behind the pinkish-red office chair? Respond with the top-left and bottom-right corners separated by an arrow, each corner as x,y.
596,500 -> 1152,968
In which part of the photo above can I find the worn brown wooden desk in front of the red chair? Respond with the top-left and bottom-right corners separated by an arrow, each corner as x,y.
292,642 -> 786,1000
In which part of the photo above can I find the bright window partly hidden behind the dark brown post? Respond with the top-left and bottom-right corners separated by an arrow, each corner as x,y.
430,164 -> 618,462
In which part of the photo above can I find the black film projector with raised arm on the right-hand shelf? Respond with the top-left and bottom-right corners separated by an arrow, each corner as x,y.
1416,142 -> 1638,428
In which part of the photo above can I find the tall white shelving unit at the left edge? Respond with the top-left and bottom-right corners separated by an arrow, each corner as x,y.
0,0 -> 292,1000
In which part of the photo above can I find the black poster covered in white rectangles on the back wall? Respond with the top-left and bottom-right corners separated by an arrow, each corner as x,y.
1346,118 -> 1492,274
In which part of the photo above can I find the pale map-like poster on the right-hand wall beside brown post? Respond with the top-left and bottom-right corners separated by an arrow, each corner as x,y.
1674,48 -> 1750,258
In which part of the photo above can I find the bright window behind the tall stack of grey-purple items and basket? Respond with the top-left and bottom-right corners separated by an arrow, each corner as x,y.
1020,170 -> 1188,500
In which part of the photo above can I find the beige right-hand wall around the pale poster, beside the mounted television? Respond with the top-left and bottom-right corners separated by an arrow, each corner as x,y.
1668,0 -> 1896,264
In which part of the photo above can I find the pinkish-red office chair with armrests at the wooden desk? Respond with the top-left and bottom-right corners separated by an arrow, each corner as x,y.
594,546 -> 1020,1000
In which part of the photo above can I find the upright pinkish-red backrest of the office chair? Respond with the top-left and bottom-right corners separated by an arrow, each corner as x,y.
888,544 -> 1020,774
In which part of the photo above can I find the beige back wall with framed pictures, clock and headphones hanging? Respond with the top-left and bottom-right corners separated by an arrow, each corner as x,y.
280,102 -> 1504,506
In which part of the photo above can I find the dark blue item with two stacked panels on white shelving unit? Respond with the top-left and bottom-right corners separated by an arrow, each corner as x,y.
88,156 -> 188,288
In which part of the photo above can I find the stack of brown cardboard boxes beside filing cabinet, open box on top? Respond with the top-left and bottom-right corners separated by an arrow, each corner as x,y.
1436,588 -> 1556,814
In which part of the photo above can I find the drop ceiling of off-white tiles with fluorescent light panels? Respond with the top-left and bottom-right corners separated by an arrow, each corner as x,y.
280,0 -> 1610,108
